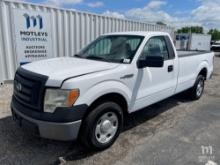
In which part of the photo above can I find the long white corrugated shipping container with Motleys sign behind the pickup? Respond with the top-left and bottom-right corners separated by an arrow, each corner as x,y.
0,0 -> 174,82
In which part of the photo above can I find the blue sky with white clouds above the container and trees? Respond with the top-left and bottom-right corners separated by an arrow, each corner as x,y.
19,0 -> 220,29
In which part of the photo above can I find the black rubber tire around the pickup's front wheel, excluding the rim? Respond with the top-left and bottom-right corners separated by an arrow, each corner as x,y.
79,102 -> 123,150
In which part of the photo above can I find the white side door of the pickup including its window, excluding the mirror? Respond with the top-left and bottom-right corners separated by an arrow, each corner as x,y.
134,36 -> 177,111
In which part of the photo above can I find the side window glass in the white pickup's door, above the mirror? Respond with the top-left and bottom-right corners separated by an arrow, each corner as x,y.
141,36 -> 169,60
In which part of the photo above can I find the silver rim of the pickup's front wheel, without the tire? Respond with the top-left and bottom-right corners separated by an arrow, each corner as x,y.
95,112 -> 118,144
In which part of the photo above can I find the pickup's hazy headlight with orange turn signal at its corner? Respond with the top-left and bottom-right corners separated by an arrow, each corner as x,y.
44,89 -> 79,113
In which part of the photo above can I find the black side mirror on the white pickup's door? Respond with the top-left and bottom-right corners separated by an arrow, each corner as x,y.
137,56 -> 164,68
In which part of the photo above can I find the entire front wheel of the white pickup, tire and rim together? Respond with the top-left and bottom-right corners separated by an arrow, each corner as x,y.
80,102 -> 123,150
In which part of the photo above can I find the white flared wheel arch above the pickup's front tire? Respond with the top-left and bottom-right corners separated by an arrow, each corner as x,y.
76,80 -> 132,106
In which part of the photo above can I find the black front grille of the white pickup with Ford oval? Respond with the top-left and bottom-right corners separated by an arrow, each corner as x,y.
14,67 -> 48,111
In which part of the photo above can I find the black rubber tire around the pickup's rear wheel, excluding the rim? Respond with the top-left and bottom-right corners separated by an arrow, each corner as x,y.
189,75 -> 205,100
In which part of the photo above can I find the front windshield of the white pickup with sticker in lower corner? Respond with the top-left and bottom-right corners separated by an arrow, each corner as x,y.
75,35 -> 144,63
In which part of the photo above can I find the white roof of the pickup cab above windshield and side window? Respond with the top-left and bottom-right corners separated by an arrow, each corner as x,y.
103,31 -> 169,36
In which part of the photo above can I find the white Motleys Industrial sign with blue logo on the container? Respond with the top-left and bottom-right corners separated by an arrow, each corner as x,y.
13,9 -> 52,65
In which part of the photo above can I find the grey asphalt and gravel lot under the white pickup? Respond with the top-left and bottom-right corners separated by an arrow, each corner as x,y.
0,56 -> 220,165
